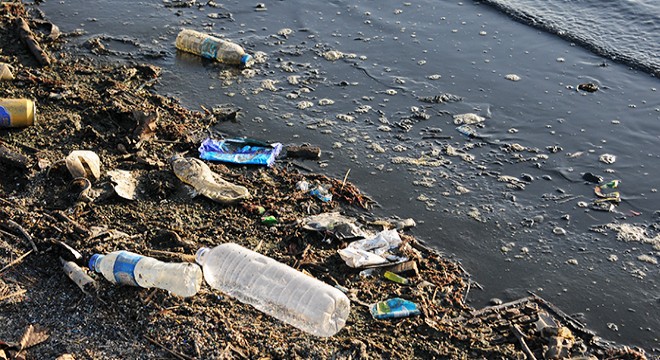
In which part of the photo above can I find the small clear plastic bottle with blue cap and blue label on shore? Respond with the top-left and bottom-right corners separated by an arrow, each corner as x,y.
89,251 -> 202,297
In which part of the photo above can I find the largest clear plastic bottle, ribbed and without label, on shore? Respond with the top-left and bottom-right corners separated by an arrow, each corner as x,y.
197,243 -> 351,337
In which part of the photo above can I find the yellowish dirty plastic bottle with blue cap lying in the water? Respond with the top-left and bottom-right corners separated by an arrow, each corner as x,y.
175,29 -> 254,67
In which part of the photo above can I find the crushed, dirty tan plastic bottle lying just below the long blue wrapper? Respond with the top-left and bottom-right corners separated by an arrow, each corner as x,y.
170,155 -> 250,203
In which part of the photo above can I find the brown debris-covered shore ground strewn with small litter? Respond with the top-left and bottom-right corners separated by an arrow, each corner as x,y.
0,2 -> 645,359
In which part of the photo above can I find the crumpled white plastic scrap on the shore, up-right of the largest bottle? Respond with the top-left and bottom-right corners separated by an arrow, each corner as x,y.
337,230 -> 401,268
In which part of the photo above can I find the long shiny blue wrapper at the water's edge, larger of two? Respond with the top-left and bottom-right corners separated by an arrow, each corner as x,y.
199,138 -> 282,166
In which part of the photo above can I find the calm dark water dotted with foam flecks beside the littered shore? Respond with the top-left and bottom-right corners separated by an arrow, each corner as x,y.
40,0 -> 660,352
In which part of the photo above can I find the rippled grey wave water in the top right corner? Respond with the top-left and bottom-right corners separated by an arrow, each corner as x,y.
485,0 -> 660,76
